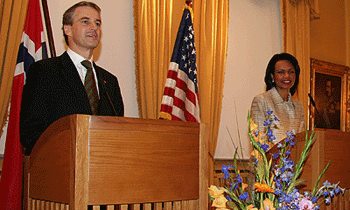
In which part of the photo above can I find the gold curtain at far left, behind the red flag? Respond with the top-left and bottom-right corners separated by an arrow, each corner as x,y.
0,0 -> 28,136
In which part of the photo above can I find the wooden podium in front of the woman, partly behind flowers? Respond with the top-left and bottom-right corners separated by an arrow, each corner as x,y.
271,129 -> 350,190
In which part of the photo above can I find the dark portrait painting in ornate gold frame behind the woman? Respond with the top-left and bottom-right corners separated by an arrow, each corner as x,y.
310,59 -> 350,131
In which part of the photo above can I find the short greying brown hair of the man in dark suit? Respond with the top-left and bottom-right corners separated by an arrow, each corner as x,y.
62,1 -> 101,45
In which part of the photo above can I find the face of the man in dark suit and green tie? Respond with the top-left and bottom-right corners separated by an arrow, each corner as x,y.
64,6 -> 101,52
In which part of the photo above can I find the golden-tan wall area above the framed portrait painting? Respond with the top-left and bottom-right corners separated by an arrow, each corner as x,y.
310,0 -> 349,65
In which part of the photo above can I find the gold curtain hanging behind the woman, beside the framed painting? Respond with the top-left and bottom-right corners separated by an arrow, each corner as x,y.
280,0 -> 318,126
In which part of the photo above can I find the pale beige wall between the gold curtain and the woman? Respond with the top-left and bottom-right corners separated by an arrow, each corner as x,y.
215,0 -> 283,159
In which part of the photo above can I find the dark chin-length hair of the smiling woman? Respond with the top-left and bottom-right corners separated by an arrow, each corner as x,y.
265,53 -> 300,95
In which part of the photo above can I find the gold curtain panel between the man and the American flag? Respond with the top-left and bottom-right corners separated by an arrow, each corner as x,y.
134,0 -> 178,119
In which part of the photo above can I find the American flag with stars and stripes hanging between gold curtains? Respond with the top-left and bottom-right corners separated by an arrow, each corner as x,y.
160,7 -> 200,122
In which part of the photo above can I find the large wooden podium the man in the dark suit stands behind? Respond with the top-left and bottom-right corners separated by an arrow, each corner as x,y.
24,115 -> 209,210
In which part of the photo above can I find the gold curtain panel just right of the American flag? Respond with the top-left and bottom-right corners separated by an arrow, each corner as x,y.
193,0 -> 229,183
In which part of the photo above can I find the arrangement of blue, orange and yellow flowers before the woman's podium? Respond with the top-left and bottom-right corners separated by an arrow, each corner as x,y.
209,111 -> 345,210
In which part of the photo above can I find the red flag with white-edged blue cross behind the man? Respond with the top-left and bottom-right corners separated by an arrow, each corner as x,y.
0,0 -> 47,209
